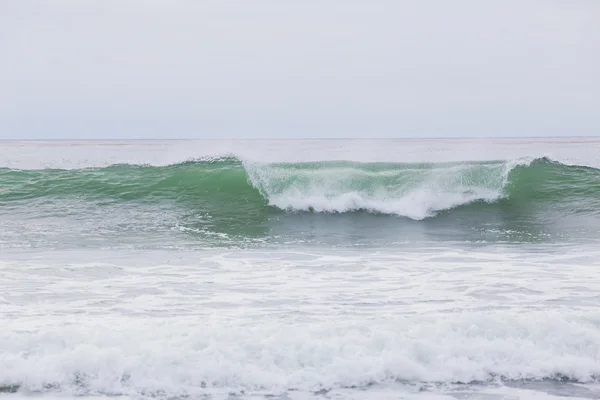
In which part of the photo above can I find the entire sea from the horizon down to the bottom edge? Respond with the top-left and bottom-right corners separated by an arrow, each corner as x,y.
0,138 -> 600,400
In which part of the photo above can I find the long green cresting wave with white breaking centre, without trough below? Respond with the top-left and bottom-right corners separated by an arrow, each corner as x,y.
0,157 -> 600,220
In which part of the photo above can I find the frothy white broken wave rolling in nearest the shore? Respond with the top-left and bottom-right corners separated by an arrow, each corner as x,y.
0,312 -> 600,397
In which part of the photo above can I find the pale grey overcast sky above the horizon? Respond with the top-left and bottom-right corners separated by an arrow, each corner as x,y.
0,0 -> 600,139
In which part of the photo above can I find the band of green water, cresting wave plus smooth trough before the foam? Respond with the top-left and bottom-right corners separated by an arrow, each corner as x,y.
0,158 -> 600,246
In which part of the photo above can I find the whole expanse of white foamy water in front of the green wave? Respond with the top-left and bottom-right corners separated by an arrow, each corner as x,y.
0,247 -> 600,396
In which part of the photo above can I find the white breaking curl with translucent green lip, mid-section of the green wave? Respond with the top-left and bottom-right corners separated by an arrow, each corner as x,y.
244,158 -> 516,220
